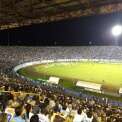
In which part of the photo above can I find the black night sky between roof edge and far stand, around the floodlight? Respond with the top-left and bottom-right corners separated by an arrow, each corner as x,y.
0,13 -> 122,46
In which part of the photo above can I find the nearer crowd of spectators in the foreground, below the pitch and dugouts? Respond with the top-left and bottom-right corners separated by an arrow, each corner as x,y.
0,72 -> 122,122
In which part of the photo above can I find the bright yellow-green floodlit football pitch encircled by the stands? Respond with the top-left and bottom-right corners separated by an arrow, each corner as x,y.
19,61 -> 122,89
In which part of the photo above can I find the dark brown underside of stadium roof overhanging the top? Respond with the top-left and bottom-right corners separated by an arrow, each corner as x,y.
0,0 -> 122,29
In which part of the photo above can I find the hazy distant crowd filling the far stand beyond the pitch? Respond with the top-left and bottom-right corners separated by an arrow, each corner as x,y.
0,46 -> 122,73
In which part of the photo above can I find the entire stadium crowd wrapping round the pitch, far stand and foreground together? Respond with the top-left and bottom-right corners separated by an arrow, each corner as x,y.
0,46 -> 122,122
